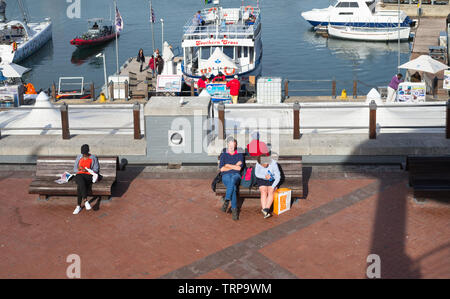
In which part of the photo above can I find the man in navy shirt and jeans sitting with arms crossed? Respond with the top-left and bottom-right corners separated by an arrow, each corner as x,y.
219,137 -> 244,220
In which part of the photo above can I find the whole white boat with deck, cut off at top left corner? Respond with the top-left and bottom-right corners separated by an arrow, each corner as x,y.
0,0 -> 52,63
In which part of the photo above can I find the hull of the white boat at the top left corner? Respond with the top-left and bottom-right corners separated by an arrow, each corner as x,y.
0,22 -> 52,63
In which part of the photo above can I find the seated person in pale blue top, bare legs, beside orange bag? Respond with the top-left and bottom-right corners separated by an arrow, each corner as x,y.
255,156 -> 281,218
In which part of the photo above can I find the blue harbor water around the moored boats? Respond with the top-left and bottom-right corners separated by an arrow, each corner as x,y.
13,0 -> 410,95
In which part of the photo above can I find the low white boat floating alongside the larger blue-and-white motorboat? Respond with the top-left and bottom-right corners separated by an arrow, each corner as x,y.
328,25 -> 411,41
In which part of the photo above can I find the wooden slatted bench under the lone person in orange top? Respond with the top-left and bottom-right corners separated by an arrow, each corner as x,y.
28,156 -> 119,200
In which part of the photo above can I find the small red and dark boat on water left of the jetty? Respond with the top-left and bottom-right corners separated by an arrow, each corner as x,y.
70,18 -> 120,48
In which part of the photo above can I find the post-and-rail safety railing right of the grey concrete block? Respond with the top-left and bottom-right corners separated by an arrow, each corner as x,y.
217,100 -> 450,140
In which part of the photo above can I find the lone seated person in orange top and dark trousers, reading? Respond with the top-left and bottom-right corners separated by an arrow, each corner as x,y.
73,144 -> 100,215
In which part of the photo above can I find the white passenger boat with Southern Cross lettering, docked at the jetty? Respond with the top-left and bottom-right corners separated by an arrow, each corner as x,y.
181,0 -> 263,85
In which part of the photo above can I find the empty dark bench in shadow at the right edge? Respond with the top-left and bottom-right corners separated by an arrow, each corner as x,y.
406,156 -> 450,197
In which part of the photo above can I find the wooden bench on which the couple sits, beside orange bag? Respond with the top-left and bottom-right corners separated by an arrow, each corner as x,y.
216,156 -> 303,198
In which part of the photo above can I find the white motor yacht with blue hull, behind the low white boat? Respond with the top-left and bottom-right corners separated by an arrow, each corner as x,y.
301,0 -> 412,28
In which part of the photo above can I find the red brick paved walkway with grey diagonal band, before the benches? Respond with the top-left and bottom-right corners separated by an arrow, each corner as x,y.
0,167 -> 450,278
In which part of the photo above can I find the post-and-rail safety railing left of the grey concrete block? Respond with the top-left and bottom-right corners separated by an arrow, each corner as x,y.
0,103 -> 141,139
